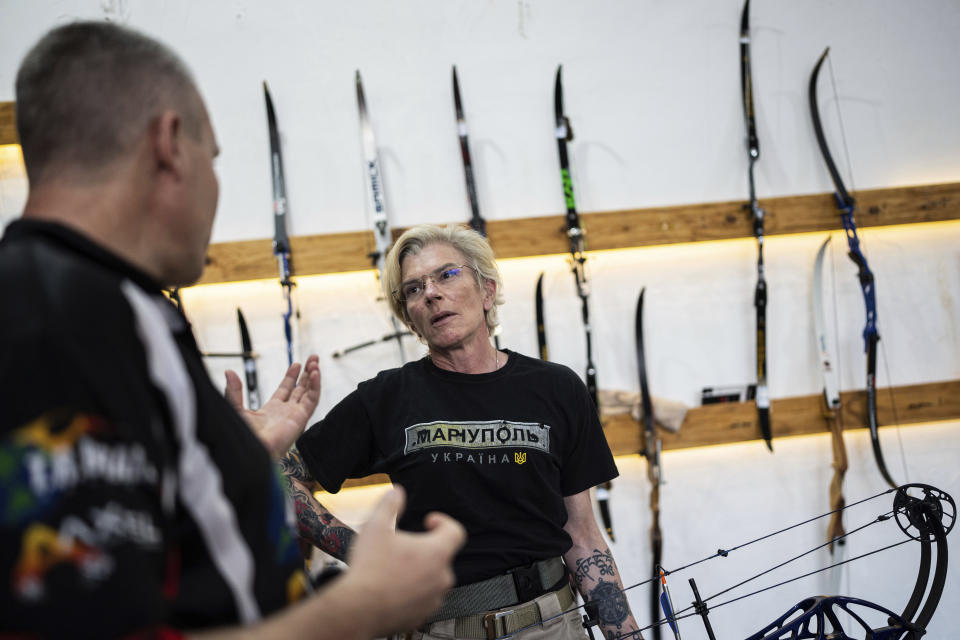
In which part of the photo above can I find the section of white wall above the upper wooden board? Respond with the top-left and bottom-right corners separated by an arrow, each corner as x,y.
0,0 -> 960,231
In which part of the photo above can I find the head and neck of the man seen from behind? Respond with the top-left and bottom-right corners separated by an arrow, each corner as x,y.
16,22 -> 219,284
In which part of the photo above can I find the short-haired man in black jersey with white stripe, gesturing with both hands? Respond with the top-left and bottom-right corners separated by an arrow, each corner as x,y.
0,22 -> 464,639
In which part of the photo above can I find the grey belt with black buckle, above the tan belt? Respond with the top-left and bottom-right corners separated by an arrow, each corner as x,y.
427,558 -> 566,623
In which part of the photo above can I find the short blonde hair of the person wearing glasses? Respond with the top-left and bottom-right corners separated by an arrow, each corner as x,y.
383,224 -> 505,335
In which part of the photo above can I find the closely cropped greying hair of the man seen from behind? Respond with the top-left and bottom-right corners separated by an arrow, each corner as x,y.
16,22 -> 206,186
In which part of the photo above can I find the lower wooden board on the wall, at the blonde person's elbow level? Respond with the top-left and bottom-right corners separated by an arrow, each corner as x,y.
332,380 -> 960,487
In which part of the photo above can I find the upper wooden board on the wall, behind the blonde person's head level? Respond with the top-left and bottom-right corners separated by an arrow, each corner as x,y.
200,182 -> 960,283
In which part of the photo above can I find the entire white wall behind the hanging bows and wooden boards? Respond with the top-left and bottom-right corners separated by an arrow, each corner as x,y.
0,0 -> 960,638
